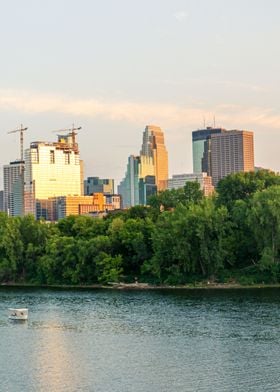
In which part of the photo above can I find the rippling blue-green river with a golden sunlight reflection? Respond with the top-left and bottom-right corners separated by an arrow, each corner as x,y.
0,288 -> 280,392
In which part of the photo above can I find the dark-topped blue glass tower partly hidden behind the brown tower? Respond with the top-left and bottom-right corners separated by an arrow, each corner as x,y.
192,127 -> 226,173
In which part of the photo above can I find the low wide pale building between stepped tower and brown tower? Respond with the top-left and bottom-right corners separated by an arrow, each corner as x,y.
168,173 -> 214,196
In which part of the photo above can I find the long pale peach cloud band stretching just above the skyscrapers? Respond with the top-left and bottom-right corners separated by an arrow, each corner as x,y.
0,90 -> 280,129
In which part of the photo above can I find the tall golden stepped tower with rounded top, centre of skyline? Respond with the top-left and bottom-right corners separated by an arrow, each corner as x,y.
140,125 -> 168,191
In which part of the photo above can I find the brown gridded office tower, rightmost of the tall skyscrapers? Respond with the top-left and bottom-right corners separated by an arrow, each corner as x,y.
208,130 -> 254,186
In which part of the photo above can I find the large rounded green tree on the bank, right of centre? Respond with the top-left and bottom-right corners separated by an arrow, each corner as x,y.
142,199 -> 232,284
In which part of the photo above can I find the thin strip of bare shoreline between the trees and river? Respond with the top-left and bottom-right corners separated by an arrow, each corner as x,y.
0,283 -> 280,291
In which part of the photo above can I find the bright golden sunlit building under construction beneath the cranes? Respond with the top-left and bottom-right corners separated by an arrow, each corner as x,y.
24,132 -> 82,219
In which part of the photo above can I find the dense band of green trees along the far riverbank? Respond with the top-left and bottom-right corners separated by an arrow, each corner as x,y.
0,170 -> 280,285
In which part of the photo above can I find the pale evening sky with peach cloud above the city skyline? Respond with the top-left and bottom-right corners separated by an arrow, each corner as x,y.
0,0 -> 280,187
